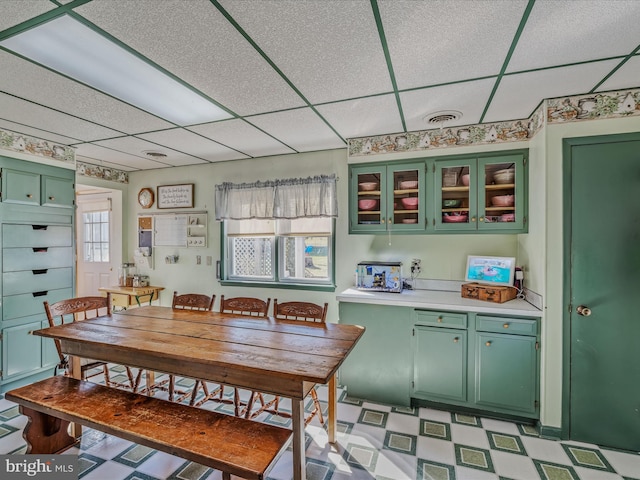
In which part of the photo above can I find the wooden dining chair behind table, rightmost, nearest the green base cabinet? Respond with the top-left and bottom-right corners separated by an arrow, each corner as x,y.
247,298 -> 329,425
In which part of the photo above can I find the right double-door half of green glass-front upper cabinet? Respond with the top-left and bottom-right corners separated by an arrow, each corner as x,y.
433,151 -> 527,233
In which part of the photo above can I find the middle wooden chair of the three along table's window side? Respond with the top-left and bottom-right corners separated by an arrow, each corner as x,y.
189,295 -> 275,417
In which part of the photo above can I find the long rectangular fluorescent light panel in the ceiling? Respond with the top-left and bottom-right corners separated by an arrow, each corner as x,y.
0,15 -> 231,125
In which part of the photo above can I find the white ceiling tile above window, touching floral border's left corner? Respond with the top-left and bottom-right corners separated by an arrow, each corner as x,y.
247,108 -> 346,152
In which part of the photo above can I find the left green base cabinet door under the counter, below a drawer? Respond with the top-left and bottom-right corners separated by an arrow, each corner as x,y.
413,326 -> 467,402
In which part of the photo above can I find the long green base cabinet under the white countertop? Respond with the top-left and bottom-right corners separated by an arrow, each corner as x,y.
339,302 -> 540,419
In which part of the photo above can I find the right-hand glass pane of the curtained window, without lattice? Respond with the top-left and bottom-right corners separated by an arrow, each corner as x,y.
282,236 -> 331,281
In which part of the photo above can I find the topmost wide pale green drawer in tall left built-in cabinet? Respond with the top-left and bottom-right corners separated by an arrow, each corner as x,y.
2,224 -> 73,248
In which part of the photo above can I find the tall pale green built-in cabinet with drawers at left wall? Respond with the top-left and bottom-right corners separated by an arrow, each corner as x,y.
0,156 -> 75,392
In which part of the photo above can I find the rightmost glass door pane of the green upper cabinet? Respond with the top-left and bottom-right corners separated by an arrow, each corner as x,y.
484,163 -> 517,222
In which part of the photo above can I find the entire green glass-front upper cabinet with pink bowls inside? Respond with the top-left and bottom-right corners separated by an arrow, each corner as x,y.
349,150 -> 528,234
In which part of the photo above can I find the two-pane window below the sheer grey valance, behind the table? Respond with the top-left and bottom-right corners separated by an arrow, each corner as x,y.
224,217 -> 334,286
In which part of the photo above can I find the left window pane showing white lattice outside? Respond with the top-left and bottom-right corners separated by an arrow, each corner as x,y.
229,237 -> 274,280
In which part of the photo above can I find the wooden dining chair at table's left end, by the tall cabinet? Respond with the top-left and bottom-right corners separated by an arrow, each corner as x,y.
44,293 -> 142,392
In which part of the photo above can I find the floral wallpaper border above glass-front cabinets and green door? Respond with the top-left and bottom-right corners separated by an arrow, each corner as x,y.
348,85 -> 640,157
